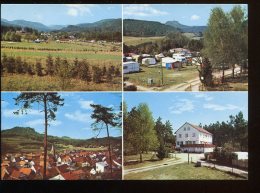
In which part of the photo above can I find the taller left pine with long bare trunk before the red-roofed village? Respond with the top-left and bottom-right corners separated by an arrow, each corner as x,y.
14,92 -> 64,179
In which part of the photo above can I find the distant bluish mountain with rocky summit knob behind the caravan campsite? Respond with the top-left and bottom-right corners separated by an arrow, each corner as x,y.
165,21 -> 207,33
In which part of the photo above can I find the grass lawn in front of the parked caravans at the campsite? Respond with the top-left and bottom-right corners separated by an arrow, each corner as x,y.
124,66 -> 198,89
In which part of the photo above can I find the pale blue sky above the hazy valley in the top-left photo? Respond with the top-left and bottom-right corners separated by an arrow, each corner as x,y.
1,4 -> 122,25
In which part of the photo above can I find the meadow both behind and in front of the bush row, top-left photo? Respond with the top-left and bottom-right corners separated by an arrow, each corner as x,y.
1,41 -> 122,91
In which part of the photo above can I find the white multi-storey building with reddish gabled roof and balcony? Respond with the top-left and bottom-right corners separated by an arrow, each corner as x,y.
175,122 -> 215,153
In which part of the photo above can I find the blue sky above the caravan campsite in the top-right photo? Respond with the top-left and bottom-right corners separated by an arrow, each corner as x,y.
123,4 -> 247,26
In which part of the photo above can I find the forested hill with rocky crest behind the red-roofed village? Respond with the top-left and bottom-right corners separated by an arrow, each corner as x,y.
1,127 -> 121,152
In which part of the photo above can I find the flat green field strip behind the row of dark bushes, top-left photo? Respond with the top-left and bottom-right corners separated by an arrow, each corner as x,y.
1,41 -> 122,64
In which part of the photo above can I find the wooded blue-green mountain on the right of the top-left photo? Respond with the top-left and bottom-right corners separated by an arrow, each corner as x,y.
60,19 -> 122,32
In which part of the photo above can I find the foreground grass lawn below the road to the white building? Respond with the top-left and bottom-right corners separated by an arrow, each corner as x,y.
124,164 -> 244,180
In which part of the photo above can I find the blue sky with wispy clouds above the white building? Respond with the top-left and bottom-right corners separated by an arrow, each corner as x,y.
124,92 -> 248,132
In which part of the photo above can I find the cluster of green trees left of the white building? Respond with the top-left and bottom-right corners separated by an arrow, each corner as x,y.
123,102 -> 175,162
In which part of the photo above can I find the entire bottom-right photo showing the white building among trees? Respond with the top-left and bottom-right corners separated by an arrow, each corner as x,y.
123,92 -> 248,180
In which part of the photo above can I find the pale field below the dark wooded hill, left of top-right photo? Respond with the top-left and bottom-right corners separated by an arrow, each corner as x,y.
123,36 -> 164,46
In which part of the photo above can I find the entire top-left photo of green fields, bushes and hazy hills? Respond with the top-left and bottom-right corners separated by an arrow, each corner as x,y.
1,4 -> 122,91
